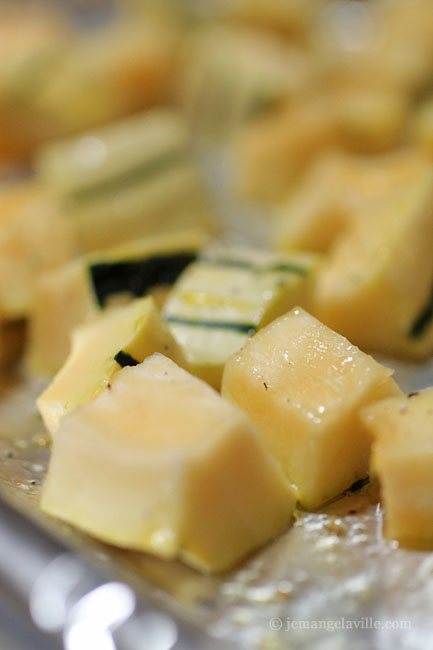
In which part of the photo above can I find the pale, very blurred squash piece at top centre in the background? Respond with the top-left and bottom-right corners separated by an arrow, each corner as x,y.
179,23 -> 311,137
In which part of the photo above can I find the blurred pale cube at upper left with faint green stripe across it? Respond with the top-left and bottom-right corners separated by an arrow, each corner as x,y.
36,109 -> 210,253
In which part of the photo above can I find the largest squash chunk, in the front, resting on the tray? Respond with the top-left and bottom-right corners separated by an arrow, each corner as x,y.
41,354 -> 294,572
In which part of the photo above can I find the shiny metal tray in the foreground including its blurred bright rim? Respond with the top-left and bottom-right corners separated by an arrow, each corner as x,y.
0,288 -> 433,650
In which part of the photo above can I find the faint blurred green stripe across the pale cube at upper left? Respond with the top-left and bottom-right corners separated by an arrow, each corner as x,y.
67,149 -> 187,204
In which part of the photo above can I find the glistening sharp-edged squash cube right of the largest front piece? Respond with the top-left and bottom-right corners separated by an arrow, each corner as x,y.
222,308 -> 400,509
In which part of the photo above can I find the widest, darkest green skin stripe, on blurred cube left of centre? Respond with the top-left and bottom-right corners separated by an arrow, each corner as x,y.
89,251 -> 197,307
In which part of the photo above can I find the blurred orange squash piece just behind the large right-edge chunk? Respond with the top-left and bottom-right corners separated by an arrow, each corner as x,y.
273,148 -> 429,252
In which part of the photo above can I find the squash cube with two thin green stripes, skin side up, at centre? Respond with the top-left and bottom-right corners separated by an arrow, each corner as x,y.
163,246 -> 319,388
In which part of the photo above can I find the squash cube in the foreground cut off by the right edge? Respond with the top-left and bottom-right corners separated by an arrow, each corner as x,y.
362,388 -> 433,548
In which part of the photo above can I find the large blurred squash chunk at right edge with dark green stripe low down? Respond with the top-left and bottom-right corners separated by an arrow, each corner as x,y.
314,166 -> 433,359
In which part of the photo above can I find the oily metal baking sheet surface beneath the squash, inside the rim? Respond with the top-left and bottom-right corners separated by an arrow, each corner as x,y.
0,356 -> 433,650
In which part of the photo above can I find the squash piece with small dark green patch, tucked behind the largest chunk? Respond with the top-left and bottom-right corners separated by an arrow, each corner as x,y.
36,297 -> 182,435
